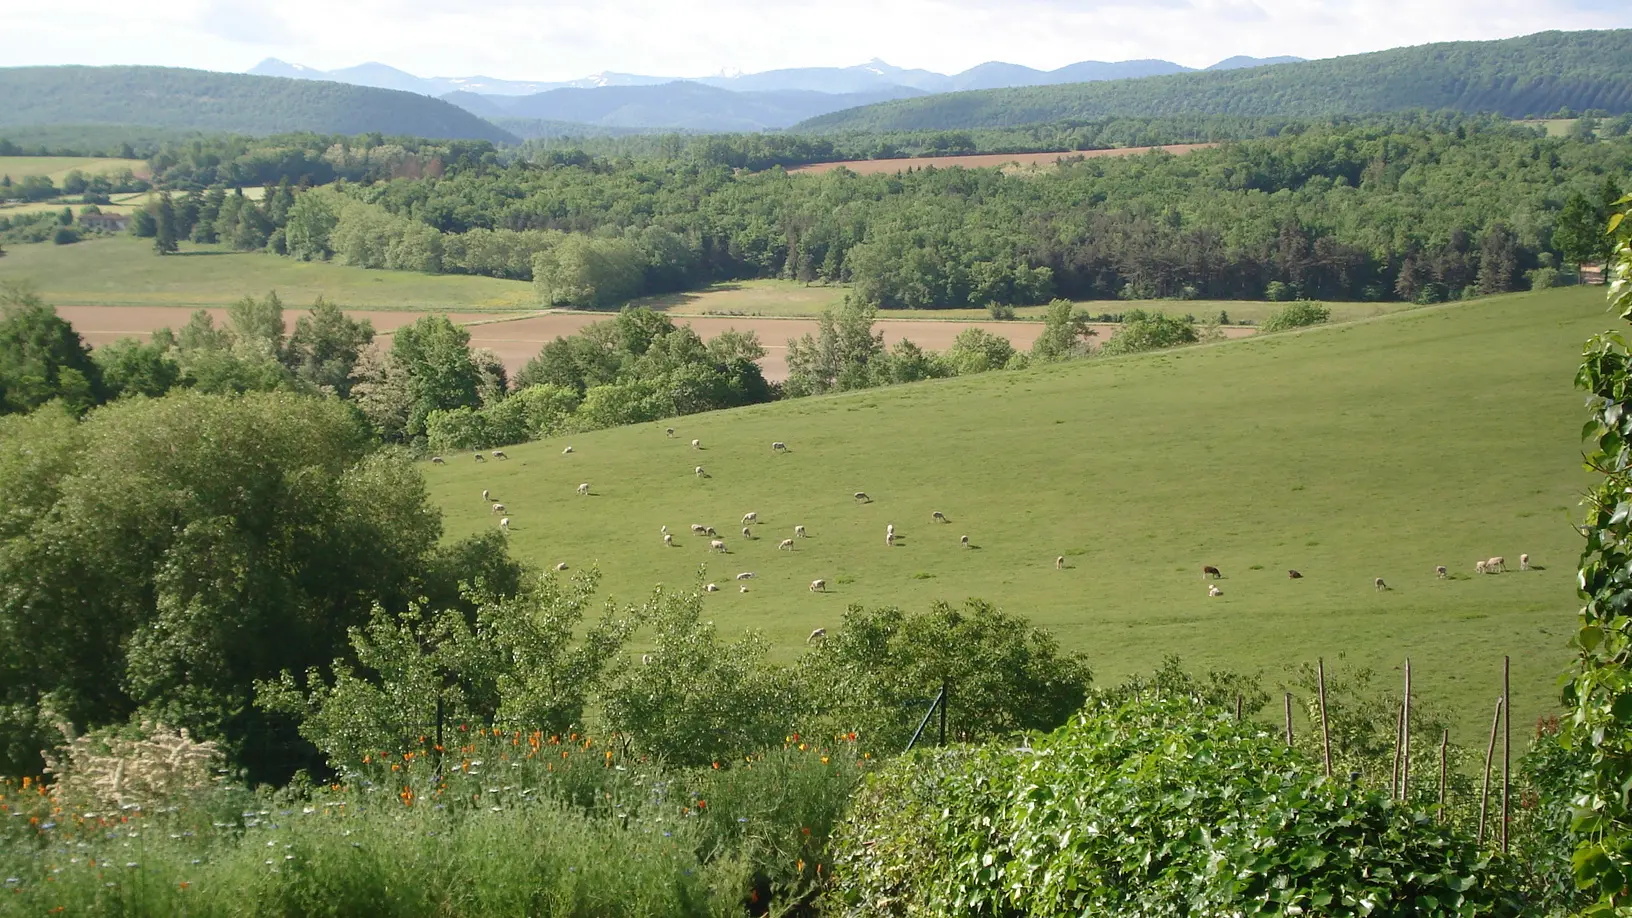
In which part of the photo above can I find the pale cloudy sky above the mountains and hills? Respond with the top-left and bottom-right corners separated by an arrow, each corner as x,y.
0,0 -> 1632,80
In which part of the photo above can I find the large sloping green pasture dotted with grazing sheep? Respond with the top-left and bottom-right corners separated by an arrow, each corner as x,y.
424,287 -> 1614,745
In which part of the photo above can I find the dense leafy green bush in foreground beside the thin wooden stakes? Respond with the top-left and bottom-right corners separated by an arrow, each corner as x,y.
829,697 -> 1519,916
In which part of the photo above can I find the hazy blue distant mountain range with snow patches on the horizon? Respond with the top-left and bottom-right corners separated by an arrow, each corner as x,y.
248,57 -> 1301,96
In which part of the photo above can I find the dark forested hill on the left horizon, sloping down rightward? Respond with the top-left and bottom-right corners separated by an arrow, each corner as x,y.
0,67 -> 516,142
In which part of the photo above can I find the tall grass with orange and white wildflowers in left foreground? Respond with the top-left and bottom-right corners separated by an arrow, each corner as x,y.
0,730 -> 865,918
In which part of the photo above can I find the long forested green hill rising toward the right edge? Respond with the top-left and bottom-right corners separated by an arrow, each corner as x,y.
795,29 -> 1632,132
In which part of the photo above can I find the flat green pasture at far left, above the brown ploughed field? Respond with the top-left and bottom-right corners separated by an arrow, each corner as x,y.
0,231 -> 537,312
